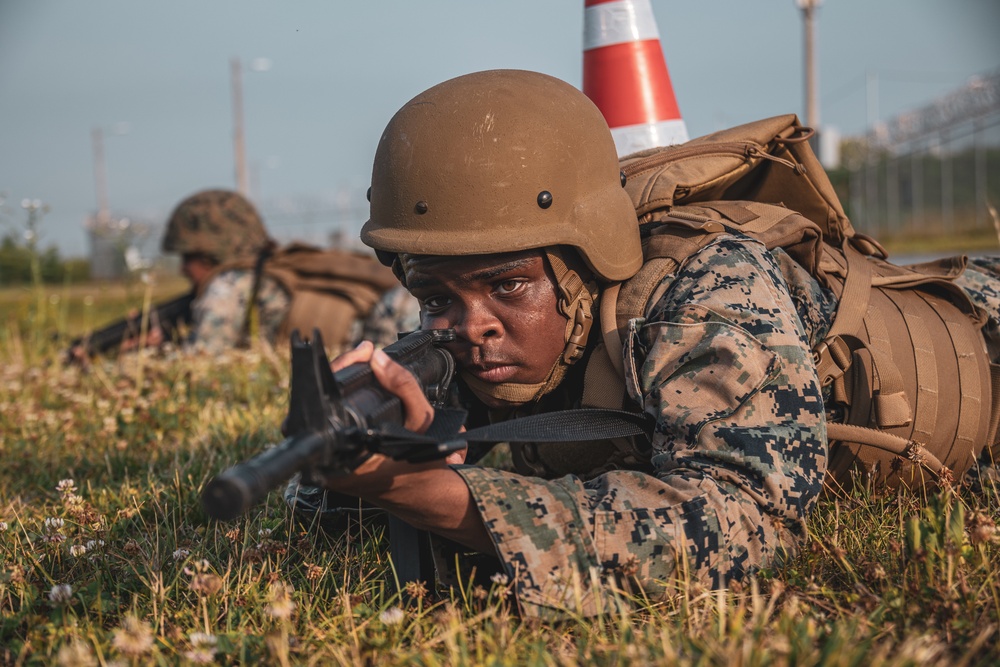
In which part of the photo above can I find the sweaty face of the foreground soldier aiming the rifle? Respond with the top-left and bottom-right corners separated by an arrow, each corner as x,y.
405,250 -> 566,396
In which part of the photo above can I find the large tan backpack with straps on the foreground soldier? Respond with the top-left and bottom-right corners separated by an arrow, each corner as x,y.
583,115 -> 1000,488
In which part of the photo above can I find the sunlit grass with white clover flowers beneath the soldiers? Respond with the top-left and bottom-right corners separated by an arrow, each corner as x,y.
0,282 -> 1000,666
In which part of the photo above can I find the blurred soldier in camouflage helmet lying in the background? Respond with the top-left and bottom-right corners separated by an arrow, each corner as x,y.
162,190 -> 418,352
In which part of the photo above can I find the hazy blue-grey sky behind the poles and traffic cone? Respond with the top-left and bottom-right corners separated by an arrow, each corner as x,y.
0,0 -> 1000,255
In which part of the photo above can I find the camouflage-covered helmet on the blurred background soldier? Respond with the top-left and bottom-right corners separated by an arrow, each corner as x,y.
162,190 -> 271,264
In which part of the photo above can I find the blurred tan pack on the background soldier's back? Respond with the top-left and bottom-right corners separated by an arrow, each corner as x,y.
209,243 -> 399,353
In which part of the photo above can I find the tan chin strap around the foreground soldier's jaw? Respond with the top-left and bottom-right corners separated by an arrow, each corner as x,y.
461,246 -> 598,405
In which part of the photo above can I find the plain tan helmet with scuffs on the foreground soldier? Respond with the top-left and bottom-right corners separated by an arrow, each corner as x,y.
361,70 -> 642,281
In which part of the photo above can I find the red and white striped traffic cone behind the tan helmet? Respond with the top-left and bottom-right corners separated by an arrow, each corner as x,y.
583,0 -> 688,155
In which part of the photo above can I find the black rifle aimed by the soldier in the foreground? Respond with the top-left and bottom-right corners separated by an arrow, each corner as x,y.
202,329 -> 465,581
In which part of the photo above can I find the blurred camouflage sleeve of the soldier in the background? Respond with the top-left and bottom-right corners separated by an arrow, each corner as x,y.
185,270 -> 290,353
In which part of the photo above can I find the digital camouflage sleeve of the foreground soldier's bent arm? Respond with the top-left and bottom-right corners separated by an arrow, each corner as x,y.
456,236 -> 826,616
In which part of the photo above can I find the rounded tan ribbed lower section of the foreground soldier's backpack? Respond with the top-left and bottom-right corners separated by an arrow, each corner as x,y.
820,267 -> 997,488
